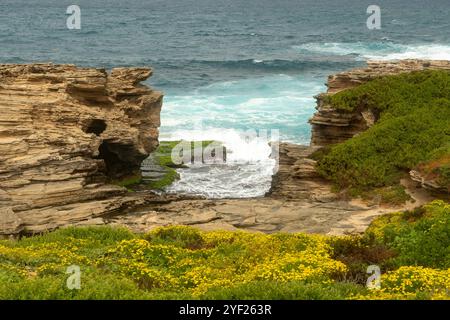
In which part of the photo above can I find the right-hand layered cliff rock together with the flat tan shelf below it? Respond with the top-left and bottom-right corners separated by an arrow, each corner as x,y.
83,61 -> 445,235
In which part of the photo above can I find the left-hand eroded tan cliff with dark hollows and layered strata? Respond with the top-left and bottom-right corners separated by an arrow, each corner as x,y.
0,64 -> 163,235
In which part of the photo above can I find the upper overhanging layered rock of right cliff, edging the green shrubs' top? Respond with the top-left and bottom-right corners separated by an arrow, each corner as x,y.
310,60 -> 450,146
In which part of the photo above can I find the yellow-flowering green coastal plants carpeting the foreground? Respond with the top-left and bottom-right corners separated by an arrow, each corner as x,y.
0,200 -> 450,299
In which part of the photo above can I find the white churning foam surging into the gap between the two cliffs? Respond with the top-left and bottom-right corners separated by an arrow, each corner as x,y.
162,128 -> 275,198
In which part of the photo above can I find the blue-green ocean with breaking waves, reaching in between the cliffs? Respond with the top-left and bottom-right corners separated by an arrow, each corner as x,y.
0,0 -> 450,197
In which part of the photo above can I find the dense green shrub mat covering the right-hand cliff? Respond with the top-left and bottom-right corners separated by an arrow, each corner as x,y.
318,71 -> 450,194
